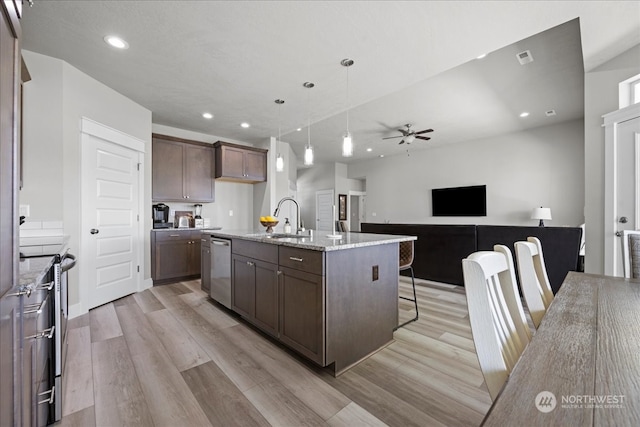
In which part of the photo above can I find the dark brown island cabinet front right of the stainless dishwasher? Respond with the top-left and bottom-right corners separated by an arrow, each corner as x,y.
231,240 -> 325,365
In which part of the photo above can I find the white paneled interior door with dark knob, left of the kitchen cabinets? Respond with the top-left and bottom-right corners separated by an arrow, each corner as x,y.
79,118 -> 143,308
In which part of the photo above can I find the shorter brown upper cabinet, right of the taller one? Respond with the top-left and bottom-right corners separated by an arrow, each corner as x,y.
213,141 -> 267,183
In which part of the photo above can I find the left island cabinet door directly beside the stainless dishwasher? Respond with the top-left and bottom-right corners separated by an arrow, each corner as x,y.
231,255 -> 256,319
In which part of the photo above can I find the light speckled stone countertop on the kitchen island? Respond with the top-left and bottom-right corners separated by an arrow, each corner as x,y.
203,230 -> 417,252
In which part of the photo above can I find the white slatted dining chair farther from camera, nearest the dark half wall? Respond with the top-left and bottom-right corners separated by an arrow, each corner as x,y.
515,237 -> 553,329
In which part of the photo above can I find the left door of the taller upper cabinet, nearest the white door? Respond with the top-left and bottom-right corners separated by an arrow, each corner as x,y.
151,138 -> 184,201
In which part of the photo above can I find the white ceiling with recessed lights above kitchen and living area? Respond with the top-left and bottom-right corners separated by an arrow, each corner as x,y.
23,0 -> 640,163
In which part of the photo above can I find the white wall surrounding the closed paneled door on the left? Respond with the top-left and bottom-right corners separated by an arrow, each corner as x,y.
20,50 -> 152,305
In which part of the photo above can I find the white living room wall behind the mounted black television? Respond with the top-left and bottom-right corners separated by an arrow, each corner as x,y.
349,120 -> 584,226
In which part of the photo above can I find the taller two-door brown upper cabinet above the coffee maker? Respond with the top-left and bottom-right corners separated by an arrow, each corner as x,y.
151,134 -> 215,202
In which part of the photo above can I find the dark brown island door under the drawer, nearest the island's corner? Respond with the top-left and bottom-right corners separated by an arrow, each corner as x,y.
280,267 -> 325,366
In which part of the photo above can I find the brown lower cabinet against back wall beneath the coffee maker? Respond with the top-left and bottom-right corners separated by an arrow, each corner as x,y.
151,230 -> 202,284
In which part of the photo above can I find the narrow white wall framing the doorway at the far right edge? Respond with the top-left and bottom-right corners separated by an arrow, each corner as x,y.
584,44 -> 640,274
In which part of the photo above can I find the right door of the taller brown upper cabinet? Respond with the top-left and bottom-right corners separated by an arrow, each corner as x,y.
183,144 -> 214,202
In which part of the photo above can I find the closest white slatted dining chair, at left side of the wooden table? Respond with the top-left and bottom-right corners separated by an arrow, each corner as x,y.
462,245 -> 531,400
